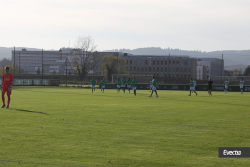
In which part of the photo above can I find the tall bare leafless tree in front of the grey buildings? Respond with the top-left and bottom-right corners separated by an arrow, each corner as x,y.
72,36 -> 99,81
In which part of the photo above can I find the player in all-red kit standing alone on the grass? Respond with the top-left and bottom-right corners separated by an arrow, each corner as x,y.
1,66 -> 14,108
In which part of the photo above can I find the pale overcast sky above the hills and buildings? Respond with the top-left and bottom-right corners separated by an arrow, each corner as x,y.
0,0 -> 250,51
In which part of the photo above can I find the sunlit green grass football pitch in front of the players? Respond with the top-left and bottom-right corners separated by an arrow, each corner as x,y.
0,86 -> 250,167
